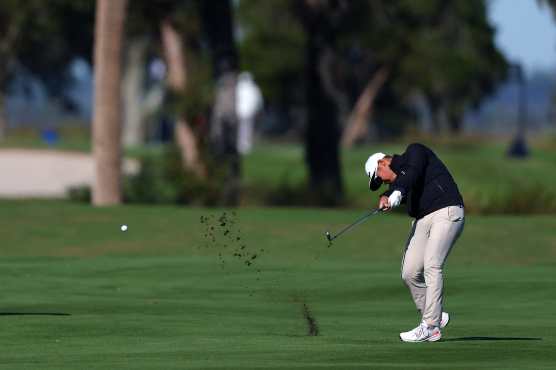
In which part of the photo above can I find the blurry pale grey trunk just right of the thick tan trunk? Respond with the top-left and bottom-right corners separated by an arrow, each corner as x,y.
122,38 -> 148,146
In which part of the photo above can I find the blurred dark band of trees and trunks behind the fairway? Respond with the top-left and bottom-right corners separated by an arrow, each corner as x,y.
0,0 -> 520,205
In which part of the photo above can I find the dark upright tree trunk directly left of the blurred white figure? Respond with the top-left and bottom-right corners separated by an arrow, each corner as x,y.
200,0 -> 241,206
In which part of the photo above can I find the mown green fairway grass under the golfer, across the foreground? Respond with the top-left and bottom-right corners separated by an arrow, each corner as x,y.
0,201 -> 556,369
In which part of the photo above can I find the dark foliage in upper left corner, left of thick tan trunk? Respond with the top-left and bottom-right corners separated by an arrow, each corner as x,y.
0,0 -> 95,94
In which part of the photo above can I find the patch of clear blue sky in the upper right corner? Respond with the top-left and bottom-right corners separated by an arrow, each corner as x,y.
489,0 -> 556,72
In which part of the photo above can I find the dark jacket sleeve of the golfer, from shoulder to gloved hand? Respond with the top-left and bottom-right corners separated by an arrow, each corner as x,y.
382,144 -> 427,199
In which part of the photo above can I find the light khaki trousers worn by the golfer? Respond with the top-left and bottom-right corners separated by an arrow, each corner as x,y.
402,206 -> 465,326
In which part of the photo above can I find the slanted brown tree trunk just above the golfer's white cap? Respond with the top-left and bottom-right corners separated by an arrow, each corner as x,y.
342,67 -> 390,148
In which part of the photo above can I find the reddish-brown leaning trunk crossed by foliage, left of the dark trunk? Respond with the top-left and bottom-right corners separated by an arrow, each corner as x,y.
160,19 -> 207,178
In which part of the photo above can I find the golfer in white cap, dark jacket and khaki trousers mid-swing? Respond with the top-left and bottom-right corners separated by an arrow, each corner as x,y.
365,144 -> 465,342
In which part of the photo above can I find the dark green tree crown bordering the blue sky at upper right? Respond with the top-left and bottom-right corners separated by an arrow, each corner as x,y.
400,0 -> 509,132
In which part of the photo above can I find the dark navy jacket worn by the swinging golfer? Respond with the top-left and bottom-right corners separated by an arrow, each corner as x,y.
382,144 -> 463,219
